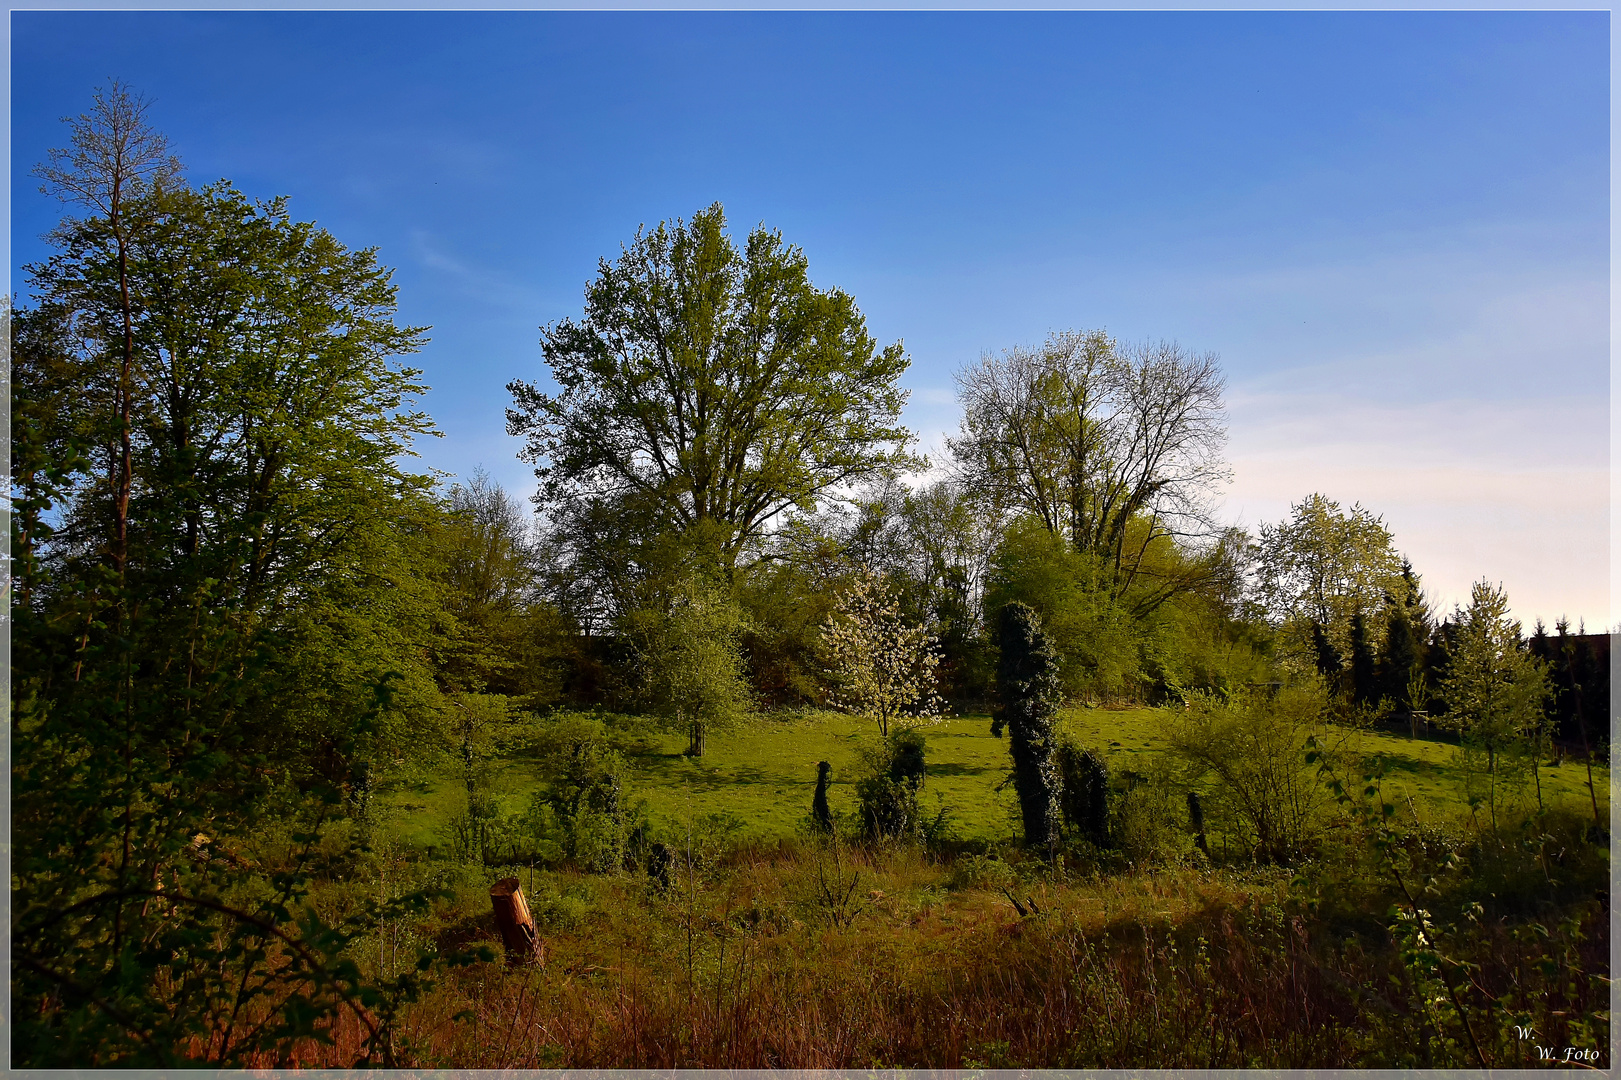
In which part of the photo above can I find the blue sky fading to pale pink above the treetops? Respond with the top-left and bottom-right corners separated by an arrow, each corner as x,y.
11,11 -> 1611,626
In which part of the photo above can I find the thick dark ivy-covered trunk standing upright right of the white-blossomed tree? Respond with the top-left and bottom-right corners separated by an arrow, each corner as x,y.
997,602 -> 1063,846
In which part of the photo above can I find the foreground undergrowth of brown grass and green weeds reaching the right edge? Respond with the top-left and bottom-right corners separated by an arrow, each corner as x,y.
259,804 -> 1608,1069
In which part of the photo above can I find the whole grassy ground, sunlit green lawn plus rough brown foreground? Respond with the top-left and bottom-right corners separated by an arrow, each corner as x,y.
297,709 -> 1610,1069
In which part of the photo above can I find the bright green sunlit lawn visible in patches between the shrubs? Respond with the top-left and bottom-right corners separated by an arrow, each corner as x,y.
383,709 -> 1610,848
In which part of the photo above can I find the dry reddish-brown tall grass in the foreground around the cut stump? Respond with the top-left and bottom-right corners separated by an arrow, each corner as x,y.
259,827 -> 1608,1069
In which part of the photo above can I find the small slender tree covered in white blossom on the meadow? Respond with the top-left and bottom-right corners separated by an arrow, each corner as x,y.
822,571 -> 940,738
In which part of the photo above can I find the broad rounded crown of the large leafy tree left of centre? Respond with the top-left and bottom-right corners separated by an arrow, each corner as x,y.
507,203 -> 914,590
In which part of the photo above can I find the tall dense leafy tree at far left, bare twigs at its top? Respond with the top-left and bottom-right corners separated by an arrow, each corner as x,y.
11,96 -> 438,1065
